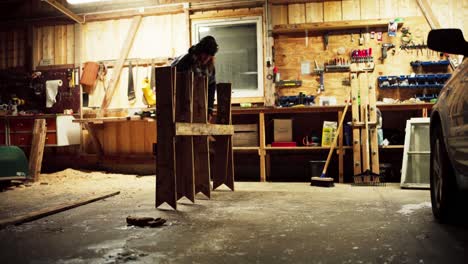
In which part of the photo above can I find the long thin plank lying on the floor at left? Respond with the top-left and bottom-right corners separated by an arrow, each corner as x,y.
0,192 -> 120,229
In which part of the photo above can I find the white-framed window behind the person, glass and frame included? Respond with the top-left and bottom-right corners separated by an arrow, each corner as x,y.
192,17 -> 263,97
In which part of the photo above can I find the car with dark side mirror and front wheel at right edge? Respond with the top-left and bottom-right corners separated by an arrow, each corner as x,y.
427,29 -> 468,222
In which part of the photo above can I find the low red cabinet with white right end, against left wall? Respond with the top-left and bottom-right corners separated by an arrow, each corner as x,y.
0,115 -> 80,147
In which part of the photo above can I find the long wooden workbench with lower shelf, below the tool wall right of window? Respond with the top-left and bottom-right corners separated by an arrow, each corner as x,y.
232,103 -> 433,182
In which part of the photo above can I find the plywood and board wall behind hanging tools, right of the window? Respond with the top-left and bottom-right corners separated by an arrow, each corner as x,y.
272,0 -> 468,103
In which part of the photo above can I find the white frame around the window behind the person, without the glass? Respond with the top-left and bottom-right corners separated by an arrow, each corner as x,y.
192,16 -> 265,98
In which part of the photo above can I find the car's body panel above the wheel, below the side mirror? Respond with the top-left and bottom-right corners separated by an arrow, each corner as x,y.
431,58 -> 468,190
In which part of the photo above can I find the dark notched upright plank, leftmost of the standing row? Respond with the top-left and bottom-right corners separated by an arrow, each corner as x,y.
156,67 -> 177,209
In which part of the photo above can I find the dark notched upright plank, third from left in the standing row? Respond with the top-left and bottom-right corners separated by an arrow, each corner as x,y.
192,76 -> 211,198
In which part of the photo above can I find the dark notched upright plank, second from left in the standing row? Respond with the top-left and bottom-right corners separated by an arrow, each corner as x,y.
175,72 -> 195,203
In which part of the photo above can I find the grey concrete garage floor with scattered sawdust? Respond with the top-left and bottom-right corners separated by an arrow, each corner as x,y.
0,173 -> 468,264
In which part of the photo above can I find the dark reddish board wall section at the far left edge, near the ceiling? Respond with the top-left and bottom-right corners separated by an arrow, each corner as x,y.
0,29 -> 27,69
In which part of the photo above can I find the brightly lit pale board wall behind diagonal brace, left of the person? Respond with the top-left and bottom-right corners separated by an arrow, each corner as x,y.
80,13 -> 189,108
